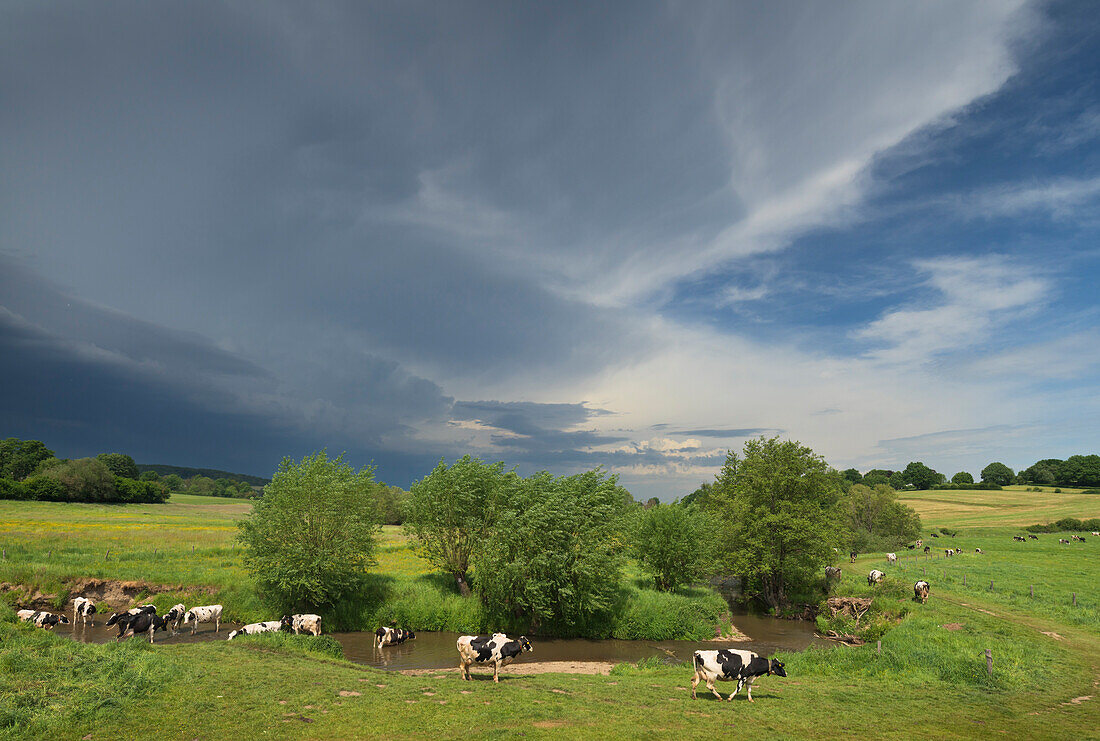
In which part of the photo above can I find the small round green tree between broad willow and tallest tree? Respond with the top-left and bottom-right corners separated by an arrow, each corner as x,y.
631,504 -> 716,591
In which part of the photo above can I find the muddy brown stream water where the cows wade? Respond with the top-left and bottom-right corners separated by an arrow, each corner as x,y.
57,615 -> 820,670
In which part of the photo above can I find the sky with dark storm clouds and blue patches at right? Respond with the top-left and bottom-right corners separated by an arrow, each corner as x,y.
0,0 -> 1100,500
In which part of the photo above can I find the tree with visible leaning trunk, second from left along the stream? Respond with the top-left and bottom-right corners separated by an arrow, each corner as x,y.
405,455 -> 519,595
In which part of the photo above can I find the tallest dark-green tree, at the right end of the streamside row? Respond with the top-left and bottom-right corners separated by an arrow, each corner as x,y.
715,438 -> 848,607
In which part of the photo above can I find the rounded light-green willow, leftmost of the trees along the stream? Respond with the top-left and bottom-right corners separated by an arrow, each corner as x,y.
238,451 -> 380,609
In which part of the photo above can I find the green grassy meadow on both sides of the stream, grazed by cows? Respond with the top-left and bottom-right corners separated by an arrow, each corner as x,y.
0,483 -> 1100,739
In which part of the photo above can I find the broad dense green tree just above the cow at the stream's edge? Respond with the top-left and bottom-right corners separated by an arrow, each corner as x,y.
475,469 -> 633,637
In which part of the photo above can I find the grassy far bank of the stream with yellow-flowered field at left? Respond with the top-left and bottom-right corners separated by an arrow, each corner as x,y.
0,495 -> 726,640
